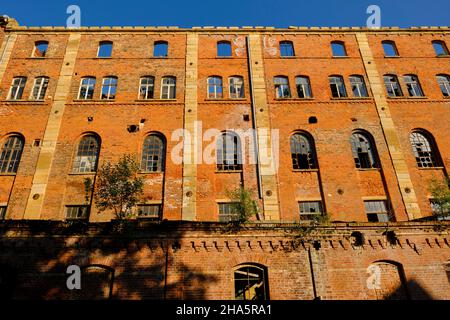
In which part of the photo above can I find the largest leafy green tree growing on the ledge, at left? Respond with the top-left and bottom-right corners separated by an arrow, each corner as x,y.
94,155 -> 144,219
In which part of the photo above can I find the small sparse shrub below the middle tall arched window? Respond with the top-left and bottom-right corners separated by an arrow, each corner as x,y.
226,186 -> 259,223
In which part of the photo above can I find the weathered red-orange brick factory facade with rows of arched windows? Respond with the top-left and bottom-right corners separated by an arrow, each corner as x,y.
0,19 -> 450,299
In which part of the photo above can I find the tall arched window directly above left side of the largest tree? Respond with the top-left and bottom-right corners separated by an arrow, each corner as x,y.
72,134 -> 100,173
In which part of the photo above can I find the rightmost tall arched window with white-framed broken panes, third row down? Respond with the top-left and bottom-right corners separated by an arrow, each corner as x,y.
410,131 -> 440,168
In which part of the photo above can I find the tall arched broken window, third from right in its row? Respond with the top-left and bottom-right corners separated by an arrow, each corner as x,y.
291,133 -> 317,170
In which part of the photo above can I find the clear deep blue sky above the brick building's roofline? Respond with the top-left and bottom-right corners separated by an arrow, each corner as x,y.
0,0 -> 450,27
